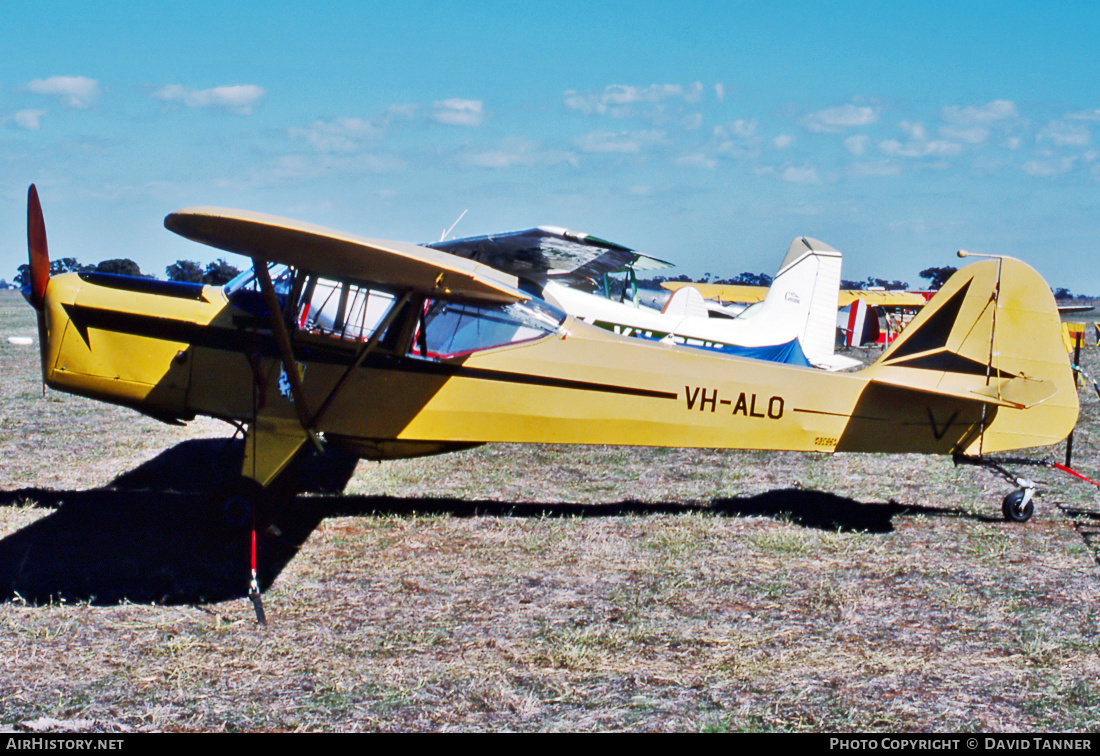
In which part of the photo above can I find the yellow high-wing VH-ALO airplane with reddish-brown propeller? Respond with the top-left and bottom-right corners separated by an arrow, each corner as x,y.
26,186 -> 1078,612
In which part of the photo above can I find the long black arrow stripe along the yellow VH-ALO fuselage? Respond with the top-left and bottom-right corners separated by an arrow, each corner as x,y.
64,305 -> 679,401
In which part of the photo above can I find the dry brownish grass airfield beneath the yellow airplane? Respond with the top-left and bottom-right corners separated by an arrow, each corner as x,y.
0,293 -> 1100,732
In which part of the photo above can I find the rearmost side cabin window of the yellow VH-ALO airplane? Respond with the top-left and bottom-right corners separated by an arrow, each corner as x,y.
413,299 -> 565,358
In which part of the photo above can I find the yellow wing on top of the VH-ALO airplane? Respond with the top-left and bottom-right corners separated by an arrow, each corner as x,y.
164,207 -> 529,302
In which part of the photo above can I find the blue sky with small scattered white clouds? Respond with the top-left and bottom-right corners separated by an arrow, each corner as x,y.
0,0 -> 1100,294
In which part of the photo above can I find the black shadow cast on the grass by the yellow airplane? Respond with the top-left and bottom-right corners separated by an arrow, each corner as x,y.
0,439 -> 992,605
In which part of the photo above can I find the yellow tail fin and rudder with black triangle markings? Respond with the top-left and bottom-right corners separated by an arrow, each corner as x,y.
865,258 -> 1078,453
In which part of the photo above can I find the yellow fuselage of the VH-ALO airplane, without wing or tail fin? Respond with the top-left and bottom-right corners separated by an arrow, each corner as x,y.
45,266 -> 1076,466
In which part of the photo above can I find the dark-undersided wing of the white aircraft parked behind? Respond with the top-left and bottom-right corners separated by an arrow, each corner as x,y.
427,226 -> 672,287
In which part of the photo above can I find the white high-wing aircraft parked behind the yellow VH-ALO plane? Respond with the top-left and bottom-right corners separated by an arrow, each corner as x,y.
427,231 -> 860,371
